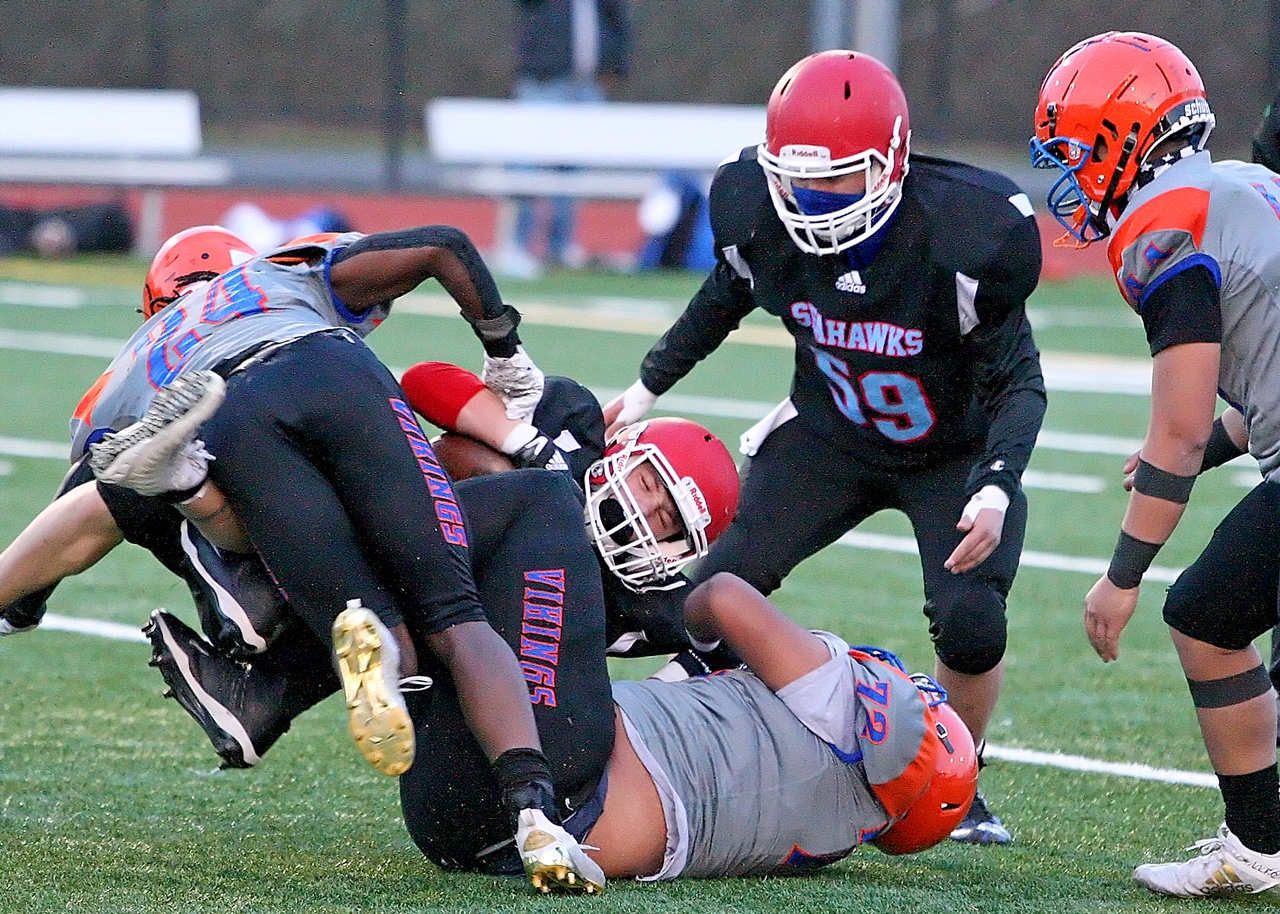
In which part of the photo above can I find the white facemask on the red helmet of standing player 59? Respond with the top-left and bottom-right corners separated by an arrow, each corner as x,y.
756,116 -> 910,255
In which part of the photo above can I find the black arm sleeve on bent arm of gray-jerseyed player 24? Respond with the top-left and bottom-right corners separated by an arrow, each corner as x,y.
333,225 -> 520,358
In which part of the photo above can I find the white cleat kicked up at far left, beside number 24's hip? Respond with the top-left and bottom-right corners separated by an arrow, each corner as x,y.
88,371 -> 227,495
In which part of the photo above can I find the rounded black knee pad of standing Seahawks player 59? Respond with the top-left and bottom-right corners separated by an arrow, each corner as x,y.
924,582 -> 1009,676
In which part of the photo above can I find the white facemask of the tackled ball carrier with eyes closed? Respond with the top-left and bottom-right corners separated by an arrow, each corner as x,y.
586,440 -> 712,591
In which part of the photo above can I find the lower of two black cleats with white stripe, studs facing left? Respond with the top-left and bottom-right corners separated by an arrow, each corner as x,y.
142,609 -> 289,768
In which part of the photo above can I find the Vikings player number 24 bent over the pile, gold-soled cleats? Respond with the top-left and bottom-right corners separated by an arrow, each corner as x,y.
10,227 -> 606,891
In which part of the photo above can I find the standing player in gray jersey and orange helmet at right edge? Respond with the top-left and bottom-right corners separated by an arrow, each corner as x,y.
1030,32 -> 1280,897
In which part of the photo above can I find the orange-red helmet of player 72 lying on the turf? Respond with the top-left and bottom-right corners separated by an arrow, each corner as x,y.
872,696 -> 978,854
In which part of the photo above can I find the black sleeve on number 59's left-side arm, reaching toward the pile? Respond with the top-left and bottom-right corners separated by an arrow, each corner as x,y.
640,260 -> 755,394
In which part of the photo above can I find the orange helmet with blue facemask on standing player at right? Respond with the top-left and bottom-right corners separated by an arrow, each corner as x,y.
1030,32 -> 1213,245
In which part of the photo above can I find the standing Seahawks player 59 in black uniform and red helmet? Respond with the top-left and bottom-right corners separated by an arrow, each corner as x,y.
605,50 -> 1044,844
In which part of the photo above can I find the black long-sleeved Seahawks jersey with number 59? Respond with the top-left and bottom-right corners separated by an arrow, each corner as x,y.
640,150 -> 1044,493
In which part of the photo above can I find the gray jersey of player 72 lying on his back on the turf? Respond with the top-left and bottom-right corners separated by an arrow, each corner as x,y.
613,636 -> 924,878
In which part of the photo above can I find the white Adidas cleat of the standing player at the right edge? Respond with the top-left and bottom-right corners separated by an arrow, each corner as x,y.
1133,824 -> 1280,899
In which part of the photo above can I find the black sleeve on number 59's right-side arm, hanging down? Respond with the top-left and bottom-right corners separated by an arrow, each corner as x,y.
966,218 -> 1046,495
